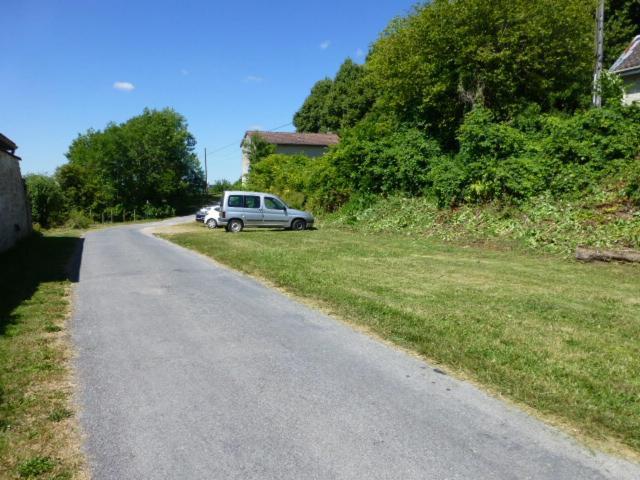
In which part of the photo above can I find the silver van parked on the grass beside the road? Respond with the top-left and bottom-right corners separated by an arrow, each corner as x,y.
218,191 -> 314,233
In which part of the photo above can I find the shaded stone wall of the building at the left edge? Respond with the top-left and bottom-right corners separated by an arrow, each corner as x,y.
0,150 -> 31,252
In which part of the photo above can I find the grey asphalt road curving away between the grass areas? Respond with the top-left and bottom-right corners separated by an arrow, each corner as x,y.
72,219 -> 640,480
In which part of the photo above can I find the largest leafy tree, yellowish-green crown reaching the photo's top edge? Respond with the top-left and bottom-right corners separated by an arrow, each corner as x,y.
367,0 -> 595,146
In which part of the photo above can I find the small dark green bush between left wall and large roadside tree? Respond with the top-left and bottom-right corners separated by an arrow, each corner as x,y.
25,174 -> 64,228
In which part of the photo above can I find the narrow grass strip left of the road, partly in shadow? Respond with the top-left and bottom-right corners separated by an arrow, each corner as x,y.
0,231 -> 86,480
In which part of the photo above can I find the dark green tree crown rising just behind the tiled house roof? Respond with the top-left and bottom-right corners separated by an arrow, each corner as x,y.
293,58 -> 373,132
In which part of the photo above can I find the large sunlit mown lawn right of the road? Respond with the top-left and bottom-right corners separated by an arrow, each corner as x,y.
161,227 -> 640,458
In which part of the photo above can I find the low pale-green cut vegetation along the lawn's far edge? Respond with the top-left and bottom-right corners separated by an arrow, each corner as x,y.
323,193 -> 640,256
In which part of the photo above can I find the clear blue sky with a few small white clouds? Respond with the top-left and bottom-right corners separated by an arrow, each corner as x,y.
0,0 -> 415,181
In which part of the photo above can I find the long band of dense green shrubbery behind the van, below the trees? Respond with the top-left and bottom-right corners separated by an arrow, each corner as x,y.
249,106 -> 640,211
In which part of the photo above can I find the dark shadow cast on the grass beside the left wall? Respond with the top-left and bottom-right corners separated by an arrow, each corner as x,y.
0,234 -> 84,335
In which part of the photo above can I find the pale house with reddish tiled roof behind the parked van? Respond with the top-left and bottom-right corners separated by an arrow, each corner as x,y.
240,130 -> 340,178
